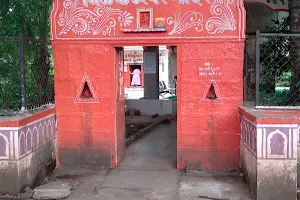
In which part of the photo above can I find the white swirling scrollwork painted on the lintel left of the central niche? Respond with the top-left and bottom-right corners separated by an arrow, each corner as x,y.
58,0 -> 133,36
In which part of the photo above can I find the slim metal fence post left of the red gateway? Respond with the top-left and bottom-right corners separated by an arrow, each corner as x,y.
19,33 -> 27,111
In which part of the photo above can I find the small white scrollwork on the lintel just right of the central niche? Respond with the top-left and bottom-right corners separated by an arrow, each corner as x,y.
167,11 -> 203,35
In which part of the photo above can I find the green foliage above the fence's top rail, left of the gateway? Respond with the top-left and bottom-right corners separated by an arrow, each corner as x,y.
0,0 -> 52,40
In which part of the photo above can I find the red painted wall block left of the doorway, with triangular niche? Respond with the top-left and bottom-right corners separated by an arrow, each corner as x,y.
52,42 -> 115,167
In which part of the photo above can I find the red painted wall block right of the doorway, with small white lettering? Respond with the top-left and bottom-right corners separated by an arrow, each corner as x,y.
177,41 -> 244,169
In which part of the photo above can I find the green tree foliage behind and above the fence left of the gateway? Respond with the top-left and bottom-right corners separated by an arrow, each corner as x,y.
0,0 -> 52,109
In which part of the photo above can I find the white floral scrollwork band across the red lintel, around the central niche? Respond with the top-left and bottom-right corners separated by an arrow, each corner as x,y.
56,0 -> 241,40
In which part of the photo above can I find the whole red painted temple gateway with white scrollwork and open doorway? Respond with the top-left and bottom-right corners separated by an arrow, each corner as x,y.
51,0 -> 245,169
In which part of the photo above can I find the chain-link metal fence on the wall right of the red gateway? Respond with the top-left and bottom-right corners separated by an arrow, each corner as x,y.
244,31 -> 300,108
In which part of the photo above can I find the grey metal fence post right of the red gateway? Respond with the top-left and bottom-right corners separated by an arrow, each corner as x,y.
255,30 -> 260,106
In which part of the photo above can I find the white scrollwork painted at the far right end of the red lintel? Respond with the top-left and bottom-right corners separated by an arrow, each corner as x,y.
206,0 -> 236,34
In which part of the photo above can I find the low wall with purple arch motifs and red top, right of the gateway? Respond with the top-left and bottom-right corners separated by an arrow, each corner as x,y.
240,106 -> 300,200
